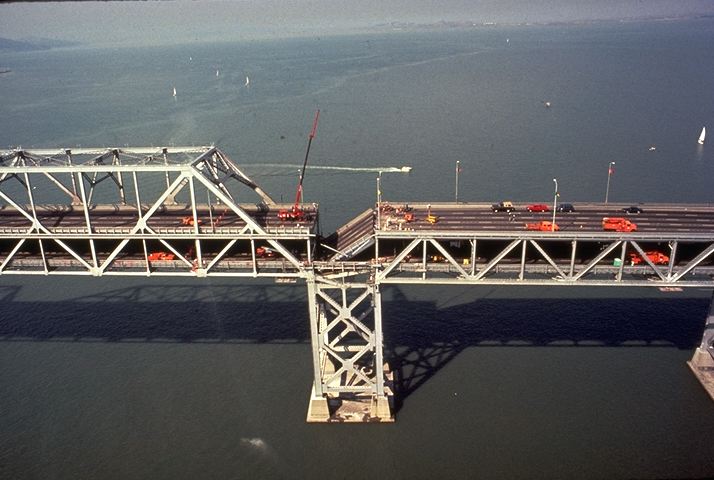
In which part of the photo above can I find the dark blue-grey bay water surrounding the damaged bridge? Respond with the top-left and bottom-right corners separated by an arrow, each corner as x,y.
0,19 -> 714,479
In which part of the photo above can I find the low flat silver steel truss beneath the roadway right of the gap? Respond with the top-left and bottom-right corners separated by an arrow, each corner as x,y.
374,232 -> 714,287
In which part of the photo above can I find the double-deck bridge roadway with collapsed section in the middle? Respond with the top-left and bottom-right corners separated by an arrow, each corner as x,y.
0,203 -> 714,272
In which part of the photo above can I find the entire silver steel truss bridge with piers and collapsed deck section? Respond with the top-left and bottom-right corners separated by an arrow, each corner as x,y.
0,146 -> 714,422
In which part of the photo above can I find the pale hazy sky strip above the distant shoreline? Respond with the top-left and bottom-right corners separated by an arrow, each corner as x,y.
0,0 -> 714,44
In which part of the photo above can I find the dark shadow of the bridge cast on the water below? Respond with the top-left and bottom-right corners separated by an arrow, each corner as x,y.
0,280 -> 709,409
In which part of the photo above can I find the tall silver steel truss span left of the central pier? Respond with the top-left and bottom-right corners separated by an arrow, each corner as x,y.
0,147 -> 316,277
